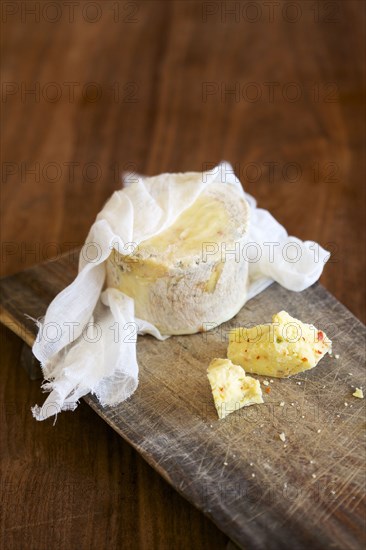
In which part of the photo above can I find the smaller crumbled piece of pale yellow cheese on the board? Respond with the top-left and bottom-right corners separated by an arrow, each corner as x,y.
207,359 -> 263,419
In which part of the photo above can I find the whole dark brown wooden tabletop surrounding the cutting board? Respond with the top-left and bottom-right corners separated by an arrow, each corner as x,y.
0,0 -> 366,550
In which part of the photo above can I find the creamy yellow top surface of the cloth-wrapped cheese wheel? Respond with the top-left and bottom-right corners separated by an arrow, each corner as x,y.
111,187 -> 245,298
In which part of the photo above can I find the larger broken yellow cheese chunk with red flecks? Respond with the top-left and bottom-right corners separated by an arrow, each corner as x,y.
227,311 -> 332,378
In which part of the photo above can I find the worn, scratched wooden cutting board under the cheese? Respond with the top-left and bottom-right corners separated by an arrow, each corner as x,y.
0,253 -> 366,550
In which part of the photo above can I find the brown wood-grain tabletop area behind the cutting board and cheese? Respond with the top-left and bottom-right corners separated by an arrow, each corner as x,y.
2,0 -> 366,320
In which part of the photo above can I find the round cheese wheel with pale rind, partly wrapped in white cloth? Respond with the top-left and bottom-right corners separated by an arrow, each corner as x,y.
107,183 -> 249,334
